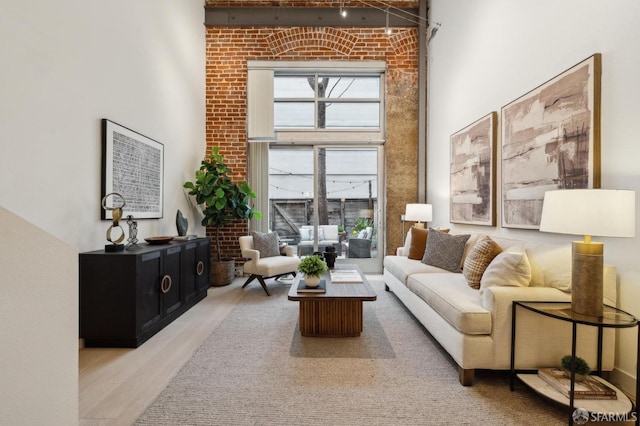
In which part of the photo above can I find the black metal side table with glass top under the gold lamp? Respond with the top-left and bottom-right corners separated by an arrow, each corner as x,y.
509,301 -> 640,425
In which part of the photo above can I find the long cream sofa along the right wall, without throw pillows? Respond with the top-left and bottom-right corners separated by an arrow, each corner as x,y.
384,232 -> 616,386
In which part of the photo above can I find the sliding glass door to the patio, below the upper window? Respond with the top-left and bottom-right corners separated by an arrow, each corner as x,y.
269,145 -> 384,273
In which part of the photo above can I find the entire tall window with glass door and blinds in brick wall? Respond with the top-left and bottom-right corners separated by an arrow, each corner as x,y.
248,61 -> 385,272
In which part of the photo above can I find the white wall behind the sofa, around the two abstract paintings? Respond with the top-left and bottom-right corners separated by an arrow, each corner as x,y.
427,0 -> 640,393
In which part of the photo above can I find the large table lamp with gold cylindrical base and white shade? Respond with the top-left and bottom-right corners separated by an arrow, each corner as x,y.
540,189 -> 636,317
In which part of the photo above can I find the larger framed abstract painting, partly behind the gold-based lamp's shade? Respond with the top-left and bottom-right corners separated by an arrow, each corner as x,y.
501,54 -> 602,229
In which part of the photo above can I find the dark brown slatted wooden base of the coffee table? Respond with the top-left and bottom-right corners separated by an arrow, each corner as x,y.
300,299 -> 362,337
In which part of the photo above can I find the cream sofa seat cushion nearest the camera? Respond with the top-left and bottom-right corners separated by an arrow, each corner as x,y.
407,273 -> 492,334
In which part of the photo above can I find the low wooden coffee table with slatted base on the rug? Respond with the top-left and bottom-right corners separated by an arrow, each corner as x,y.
289,264 -> 378,337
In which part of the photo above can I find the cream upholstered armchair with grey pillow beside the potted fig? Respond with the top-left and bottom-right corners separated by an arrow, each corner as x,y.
239,232 -> 300,296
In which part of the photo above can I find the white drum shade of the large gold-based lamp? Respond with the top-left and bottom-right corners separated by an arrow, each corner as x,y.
540,189 -> 636,237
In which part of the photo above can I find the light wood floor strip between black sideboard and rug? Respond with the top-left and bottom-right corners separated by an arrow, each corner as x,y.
79,278 -> 250,426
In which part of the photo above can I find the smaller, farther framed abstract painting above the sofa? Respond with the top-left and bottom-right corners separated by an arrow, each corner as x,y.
449,112 -> 497,226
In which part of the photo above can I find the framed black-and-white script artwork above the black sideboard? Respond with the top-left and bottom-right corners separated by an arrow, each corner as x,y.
102,119 -> 164,220
